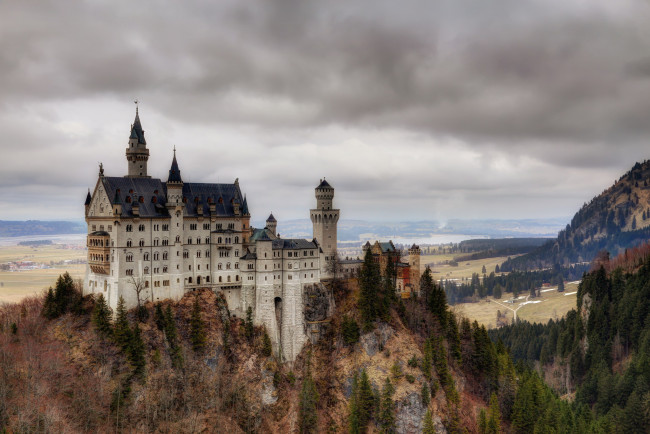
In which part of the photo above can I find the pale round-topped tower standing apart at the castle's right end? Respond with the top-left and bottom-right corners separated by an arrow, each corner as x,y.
310,179 -> 340,277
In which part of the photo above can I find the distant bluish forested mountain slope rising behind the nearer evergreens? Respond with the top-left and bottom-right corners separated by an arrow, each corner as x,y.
501,161 -> 650,271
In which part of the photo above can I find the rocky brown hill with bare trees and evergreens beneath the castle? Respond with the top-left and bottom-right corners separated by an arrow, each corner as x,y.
0,272 -> 532,433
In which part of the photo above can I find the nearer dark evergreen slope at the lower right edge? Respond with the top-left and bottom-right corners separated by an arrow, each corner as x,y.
489,245 -> 650,432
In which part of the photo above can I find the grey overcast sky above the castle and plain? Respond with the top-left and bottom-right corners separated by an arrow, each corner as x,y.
0,0 -> 650,221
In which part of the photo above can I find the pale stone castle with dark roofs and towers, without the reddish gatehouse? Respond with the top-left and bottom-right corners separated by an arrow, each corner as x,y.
84,108 -> 340,361
